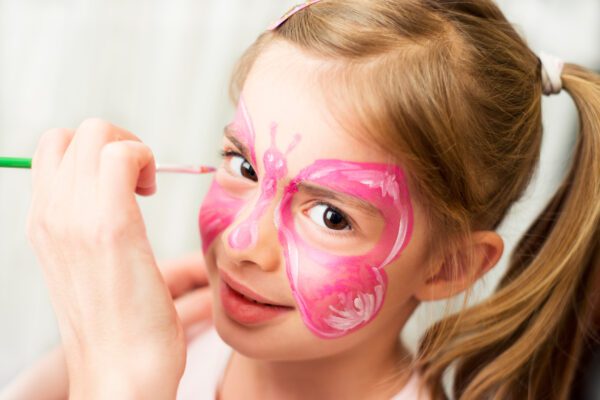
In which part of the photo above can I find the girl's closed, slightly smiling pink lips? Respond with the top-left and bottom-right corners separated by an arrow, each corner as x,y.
219,275 -> 293,325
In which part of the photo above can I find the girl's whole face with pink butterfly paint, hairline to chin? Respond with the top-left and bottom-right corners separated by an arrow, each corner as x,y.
200,43 -> 434,360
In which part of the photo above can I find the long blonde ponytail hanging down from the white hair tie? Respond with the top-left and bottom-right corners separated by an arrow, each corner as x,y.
419,64 -> 600,400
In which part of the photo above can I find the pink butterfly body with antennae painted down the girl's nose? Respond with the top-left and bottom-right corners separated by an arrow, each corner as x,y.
228,123 -> 300,250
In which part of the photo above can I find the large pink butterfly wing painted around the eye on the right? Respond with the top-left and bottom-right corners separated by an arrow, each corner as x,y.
276,160 -> 413,338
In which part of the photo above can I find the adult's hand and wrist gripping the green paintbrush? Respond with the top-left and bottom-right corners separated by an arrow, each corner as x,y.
28,119 -> 186,399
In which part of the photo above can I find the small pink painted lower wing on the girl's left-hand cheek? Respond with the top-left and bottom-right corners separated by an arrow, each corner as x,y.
198,179 -> 244,252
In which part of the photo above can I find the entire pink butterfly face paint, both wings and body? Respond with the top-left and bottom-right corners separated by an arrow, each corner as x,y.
199,95 -> 413,338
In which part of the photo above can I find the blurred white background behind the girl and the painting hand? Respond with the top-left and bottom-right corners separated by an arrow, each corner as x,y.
0,0 -> 600,387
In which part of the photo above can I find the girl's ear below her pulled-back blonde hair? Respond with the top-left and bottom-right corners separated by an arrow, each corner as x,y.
414,231 -> 504,301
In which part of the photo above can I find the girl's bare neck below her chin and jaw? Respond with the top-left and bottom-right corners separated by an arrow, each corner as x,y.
219,330 -> 411,400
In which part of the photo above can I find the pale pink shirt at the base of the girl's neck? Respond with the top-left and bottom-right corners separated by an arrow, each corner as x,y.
177,328 -> 428,400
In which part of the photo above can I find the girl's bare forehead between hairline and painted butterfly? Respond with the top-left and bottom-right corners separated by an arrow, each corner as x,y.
237,44 -> 389,175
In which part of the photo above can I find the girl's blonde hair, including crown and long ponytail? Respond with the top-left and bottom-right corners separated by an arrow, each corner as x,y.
231,0 -> 600,399
